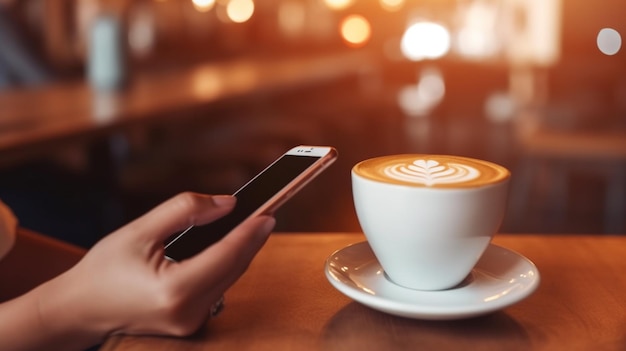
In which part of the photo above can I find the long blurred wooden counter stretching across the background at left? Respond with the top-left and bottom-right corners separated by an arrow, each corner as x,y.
0,51 -> 374,165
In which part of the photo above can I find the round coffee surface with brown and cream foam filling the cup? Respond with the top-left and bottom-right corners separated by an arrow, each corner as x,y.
353,154 -> 510,188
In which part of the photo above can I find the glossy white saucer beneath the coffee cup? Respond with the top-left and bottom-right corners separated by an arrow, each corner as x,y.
325,242 -> 540,320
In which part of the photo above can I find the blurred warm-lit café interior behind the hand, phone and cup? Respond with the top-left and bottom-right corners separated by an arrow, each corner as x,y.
0,0 -> 626,247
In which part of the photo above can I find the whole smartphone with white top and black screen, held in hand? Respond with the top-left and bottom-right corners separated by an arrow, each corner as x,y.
165,145 -> 337,261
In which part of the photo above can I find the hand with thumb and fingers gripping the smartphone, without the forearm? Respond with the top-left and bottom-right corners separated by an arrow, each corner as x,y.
31,193 -> 275,350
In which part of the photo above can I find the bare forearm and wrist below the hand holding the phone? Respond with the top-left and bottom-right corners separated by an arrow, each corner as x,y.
0,276 -> 105,351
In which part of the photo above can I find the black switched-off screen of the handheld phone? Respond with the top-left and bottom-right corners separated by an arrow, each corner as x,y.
165,155 -> 320,261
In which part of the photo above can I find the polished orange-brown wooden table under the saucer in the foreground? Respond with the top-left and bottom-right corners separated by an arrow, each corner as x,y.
102,233 -> 626,351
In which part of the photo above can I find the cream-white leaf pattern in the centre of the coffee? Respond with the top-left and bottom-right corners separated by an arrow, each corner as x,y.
384,159 -> 480,186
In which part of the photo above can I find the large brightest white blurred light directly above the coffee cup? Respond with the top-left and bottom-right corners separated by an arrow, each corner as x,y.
400,22 -> 450,61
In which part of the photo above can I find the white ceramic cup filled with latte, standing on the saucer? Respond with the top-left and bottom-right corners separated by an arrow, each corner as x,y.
352,154 -> 510,290
